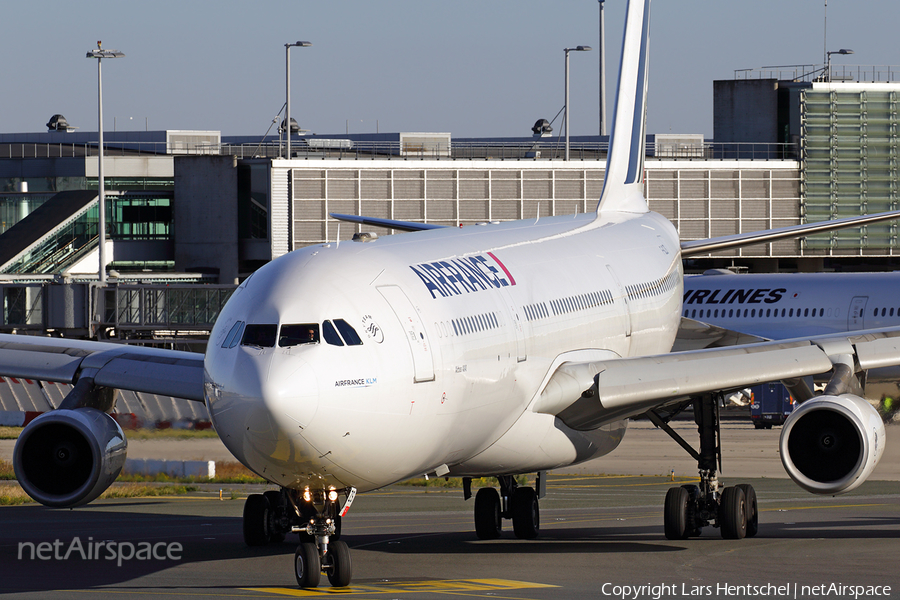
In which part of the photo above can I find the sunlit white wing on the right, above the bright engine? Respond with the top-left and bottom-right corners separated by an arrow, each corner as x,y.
532,328 -> 900,430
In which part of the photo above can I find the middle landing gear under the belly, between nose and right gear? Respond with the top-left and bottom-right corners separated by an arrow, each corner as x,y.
472,472 -> 546,540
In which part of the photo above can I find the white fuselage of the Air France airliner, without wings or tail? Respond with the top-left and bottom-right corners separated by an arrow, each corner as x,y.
205,213 -> 682,491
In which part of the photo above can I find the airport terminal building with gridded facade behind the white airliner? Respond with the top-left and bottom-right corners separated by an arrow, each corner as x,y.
0,71 -> 900,422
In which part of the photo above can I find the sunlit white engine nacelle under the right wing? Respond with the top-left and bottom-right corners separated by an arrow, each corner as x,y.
779,394 -> 885,494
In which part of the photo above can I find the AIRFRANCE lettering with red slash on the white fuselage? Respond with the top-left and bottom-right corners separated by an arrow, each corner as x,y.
409,252 -> 516,298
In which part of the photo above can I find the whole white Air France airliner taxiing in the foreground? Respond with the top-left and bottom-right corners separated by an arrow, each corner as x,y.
0,1 -> 900,587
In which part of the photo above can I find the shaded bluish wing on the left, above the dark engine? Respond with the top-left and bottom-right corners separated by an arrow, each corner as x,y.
0,334 -> 204,402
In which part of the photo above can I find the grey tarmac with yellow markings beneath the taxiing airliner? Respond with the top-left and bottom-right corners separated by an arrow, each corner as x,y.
0,423 -> 900,599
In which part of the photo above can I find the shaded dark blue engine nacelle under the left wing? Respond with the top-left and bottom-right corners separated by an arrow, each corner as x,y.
13,408 -> 127,508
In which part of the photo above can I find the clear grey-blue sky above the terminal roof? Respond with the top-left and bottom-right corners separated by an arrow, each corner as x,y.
0,0 -> 900,137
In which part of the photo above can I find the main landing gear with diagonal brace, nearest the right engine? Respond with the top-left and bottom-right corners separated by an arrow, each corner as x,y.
647,395 -> 759,540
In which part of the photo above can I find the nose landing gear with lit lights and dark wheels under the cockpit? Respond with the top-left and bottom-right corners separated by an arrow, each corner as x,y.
244,488 -> 356,588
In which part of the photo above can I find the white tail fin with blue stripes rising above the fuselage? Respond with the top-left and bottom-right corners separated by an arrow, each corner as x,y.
597,0 -> 650,215
